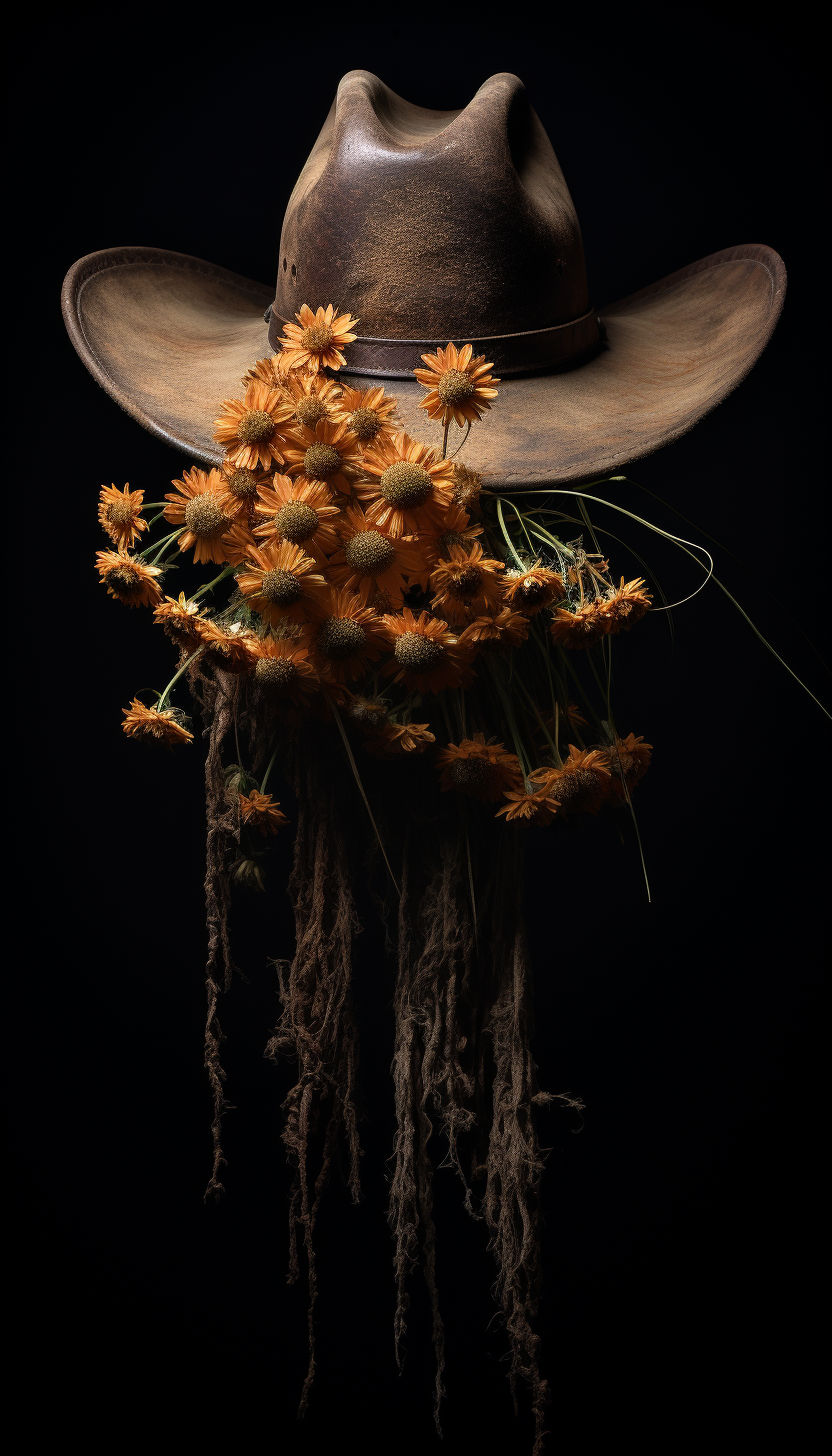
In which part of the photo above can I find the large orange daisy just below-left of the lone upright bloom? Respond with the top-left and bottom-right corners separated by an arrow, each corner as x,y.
356,430 -> 453,547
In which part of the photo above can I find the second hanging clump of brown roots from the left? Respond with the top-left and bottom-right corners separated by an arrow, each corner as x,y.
265,731 -> 361,1417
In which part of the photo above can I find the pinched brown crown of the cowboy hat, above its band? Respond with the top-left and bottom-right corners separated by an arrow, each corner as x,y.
274,71 -> 590,339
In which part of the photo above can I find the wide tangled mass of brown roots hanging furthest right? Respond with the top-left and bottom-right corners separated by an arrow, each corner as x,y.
389,768 -> 571,1456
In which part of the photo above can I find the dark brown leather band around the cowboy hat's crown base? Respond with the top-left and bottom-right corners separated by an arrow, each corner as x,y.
268,309 -> 603,379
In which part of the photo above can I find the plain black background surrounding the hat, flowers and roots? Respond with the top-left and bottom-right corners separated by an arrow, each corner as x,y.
37,19 -> 828,1453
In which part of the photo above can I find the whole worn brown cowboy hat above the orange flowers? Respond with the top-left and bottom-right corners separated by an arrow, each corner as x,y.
63,71 -> 785,489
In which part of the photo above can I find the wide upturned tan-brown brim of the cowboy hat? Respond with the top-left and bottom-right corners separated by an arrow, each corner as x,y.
61,245 -> 785,491
